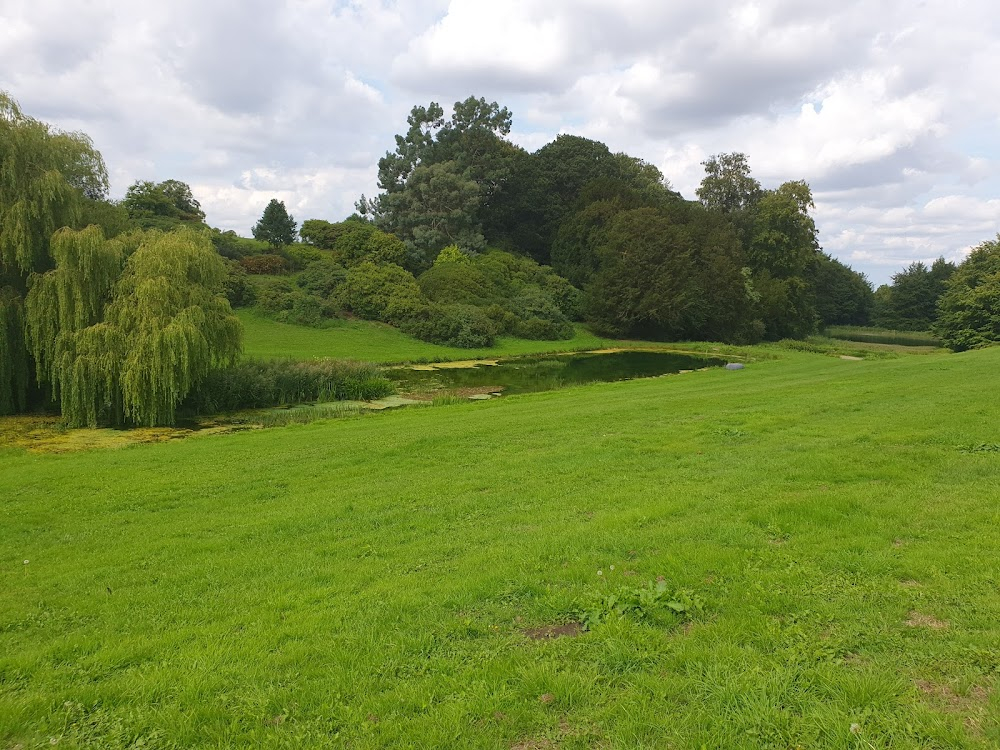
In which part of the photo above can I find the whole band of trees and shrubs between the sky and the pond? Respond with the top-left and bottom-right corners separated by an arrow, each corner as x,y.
0,93 -> 1000,424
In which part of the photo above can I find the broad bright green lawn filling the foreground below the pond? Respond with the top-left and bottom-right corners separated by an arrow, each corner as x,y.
0,349 -> 1000,748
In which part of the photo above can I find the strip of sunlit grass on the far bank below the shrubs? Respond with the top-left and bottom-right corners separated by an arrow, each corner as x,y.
237,310 -> 618,363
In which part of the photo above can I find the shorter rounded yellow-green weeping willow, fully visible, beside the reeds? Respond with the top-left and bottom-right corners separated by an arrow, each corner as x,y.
27,227 -> 242,426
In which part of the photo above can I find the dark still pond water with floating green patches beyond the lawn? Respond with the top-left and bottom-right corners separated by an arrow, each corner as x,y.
386,351 -> 726,396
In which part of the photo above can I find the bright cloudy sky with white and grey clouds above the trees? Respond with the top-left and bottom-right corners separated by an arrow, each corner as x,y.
0,0 -> 1000,284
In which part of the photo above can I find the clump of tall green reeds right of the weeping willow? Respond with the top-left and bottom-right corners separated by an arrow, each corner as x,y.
184,359 -> 395,414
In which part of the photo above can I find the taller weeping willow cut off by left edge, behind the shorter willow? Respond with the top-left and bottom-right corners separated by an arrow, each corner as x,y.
0,91 -> 108,414
